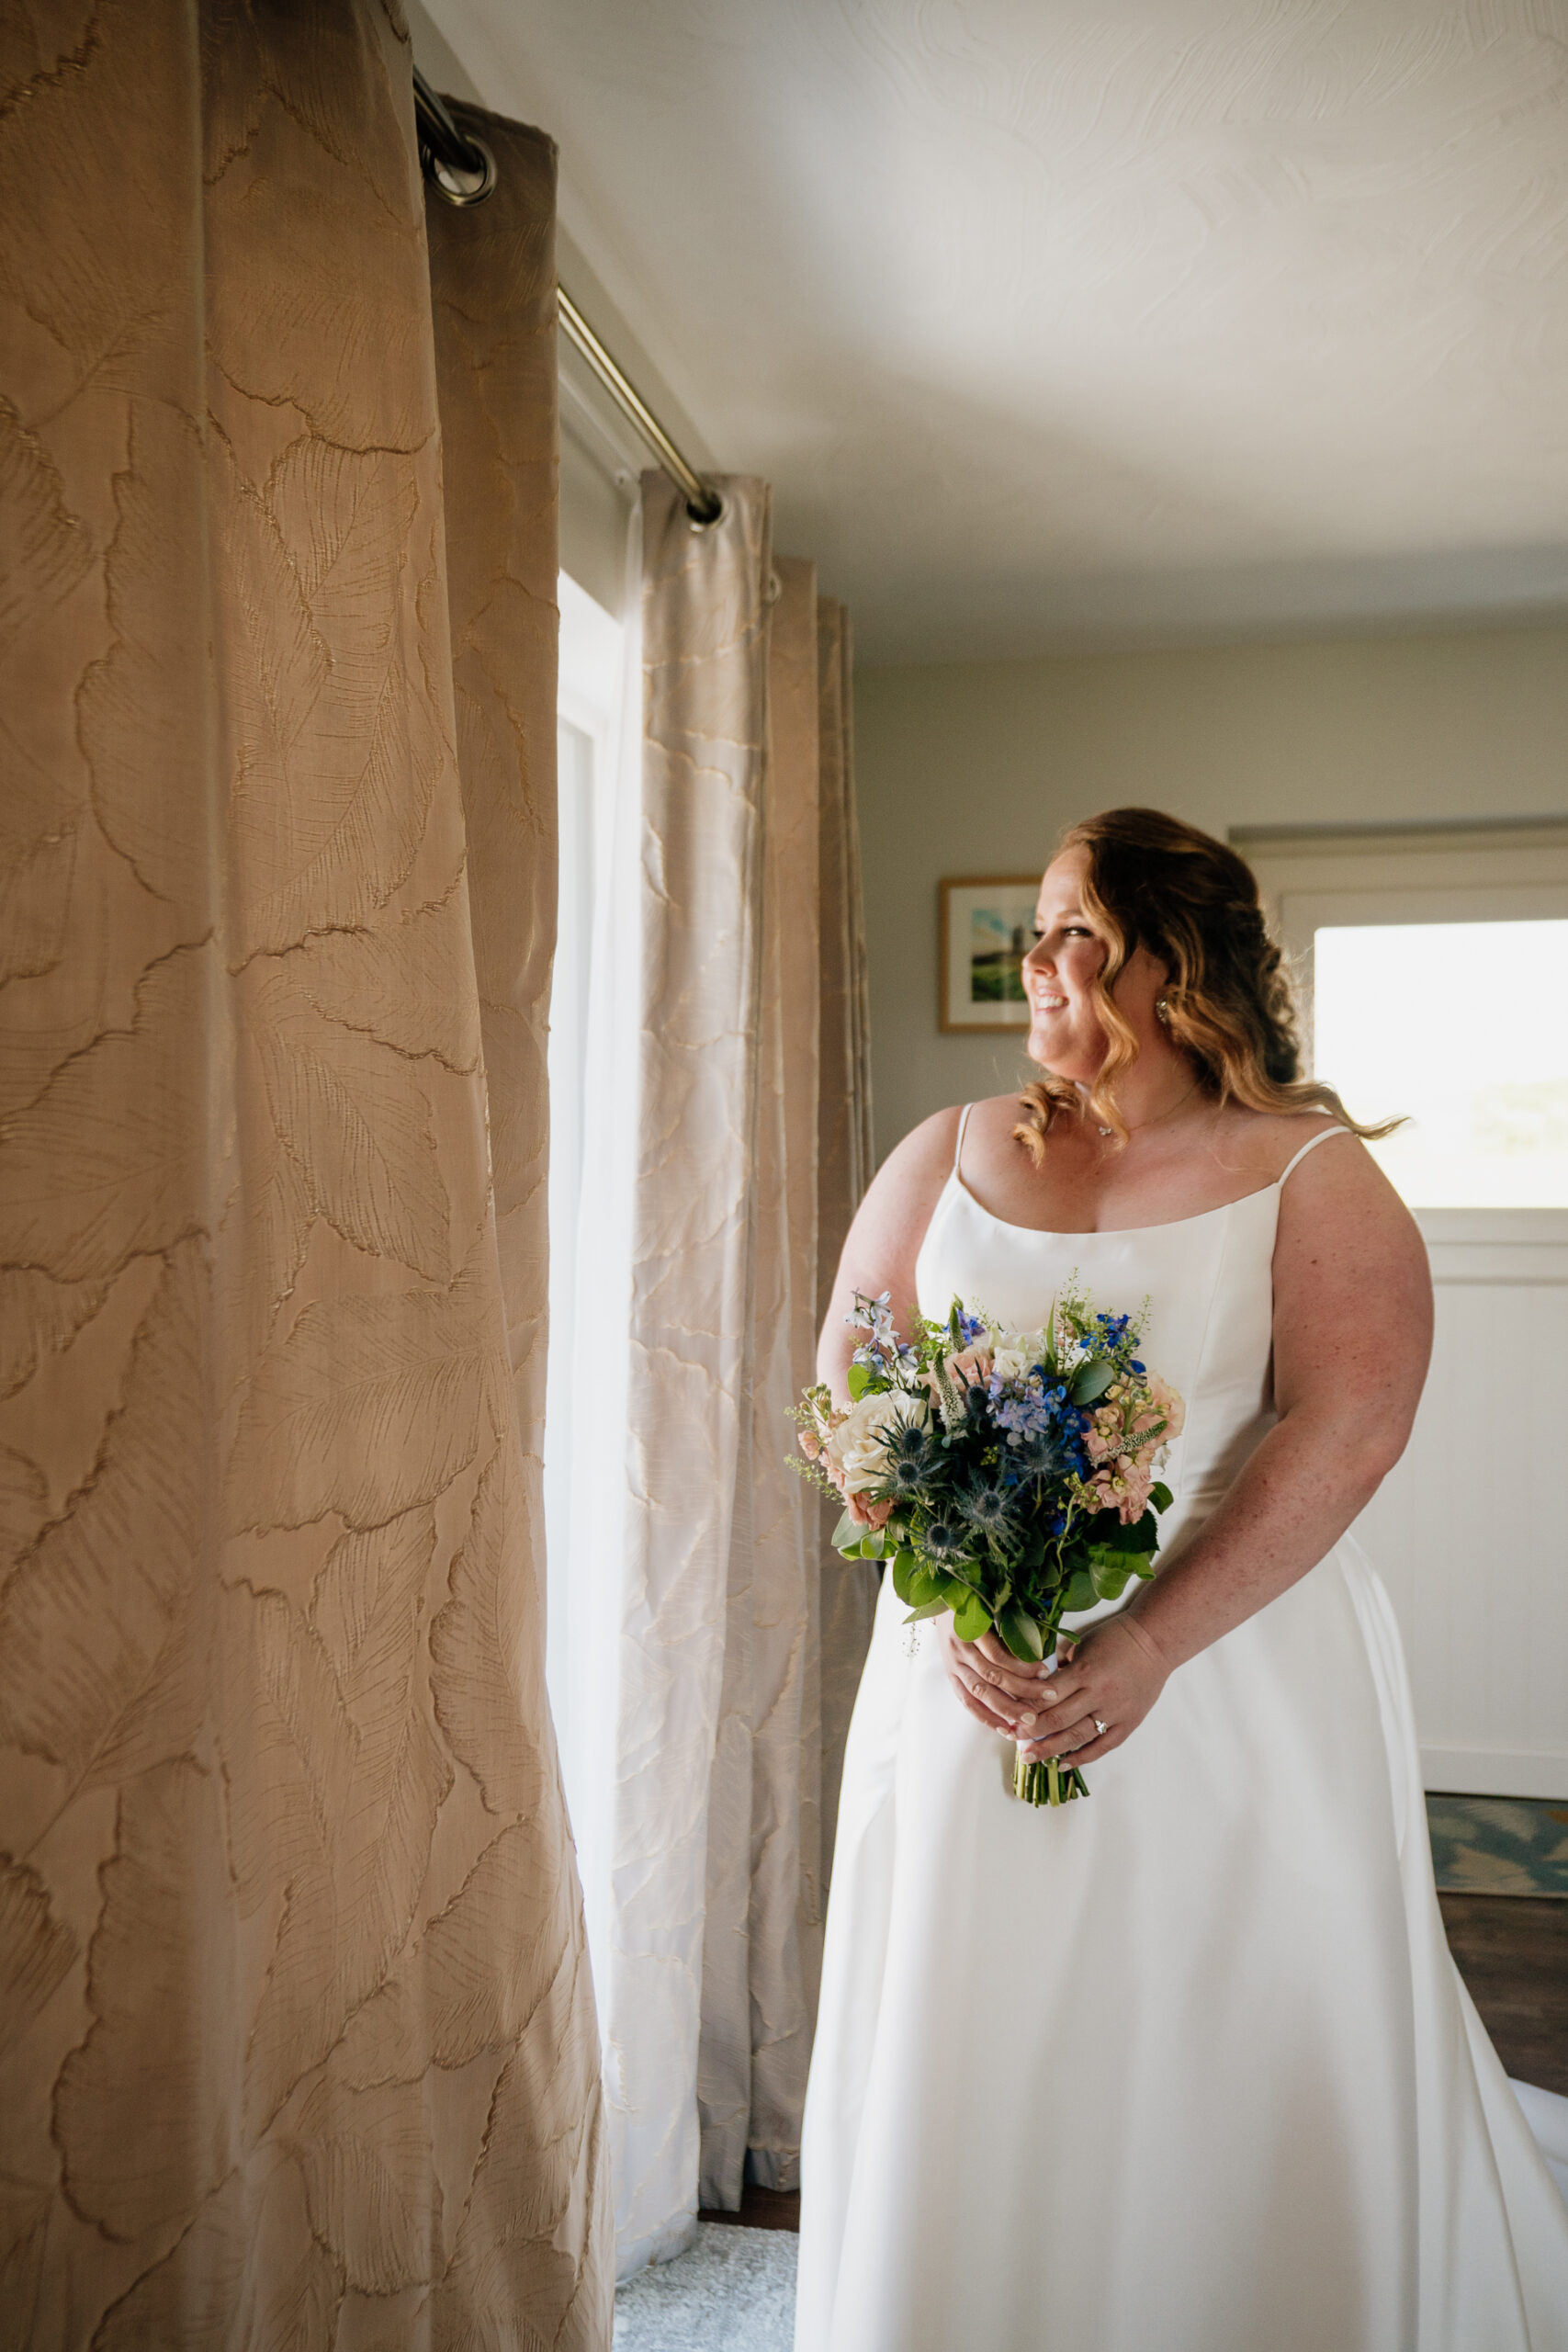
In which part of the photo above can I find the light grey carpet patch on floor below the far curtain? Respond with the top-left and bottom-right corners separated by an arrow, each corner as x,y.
616,2221 -> 799,2352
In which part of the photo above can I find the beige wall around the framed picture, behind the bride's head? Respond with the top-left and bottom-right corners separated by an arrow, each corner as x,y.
856,623 -> 1568,1158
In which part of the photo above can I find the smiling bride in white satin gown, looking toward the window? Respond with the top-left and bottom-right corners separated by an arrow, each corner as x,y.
795,809 -> 1568,2352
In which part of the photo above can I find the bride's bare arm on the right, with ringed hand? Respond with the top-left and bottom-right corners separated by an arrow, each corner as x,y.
989,1141 -> 1432,1761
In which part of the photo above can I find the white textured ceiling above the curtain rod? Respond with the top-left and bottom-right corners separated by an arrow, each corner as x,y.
415,0 -> 1568,661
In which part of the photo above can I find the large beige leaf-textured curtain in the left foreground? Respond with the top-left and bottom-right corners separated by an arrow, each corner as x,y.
0,0 -> 609,2352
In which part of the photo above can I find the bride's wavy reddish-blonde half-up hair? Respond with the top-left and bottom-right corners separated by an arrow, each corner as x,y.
1013,809 -> 1399,1167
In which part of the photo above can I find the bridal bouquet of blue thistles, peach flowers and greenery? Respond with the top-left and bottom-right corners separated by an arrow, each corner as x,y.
795,1286 -> 1182,1804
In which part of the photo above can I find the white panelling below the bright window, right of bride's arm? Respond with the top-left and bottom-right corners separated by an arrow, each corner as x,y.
1357,1209 -> 1568,1799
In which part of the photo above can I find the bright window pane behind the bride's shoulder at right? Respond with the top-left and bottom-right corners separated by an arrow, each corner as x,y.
1312,922 -> 1568,1209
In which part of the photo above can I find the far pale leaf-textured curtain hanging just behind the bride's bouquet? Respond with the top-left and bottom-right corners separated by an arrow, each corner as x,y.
606,492 -> 872,2275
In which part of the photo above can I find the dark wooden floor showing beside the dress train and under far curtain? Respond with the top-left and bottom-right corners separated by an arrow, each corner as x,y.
703,1895 -> 1568,2230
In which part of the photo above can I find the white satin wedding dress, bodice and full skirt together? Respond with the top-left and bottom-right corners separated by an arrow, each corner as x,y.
795,1131 -> 1568,2352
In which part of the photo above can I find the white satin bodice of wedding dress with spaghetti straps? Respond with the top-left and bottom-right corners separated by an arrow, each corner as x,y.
915,1126 -> 1345,1543
